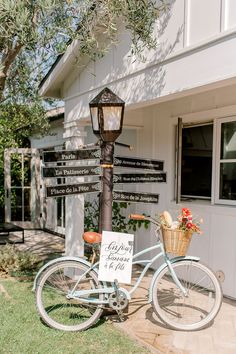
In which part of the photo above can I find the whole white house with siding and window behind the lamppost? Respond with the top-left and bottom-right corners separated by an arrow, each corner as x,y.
37,0 -> 236,298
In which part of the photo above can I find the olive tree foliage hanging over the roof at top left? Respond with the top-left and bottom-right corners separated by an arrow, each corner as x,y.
0,0 -> 167,103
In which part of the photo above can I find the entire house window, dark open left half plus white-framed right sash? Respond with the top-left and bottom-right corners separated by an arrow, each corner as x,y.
176,117 -> 236,205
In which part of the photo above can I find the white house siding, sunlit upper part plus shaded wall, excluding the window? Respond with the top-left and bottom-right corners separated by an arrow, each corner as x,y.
58,0 -> 236,298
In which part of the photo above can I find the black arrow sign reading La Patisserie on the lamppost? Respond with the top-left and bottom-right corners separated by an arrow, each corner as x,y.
43,166 -> 101,178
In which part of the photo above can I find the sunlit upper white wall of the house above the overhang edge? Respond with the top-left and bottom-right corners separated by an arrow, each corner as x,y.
62,0 -> 236,121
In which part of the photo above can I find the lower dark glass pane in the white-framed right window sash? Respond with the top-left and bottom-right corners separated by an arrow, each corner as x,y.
220,163 -> 236,200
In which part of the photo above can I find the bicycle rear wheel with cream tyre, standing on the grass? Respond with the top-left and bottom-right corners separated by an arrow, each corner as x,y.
36,261 -> 104,331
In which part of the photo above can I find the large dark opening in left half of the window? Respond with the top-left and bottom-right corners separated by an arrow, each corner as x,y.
181,124 -> 213,198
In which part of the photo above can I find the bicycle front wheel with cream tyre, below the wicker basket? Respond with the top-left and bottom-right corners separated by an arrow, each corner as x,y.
152,260 -> 222,331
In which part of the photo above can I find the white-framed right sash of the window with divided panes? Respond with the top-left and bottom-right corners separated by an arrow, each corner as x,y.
215,117 -> 236,205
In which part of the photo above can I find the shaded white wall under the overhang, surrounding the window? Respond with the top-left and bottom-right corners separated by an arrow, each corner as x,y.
126,87 -> 236,298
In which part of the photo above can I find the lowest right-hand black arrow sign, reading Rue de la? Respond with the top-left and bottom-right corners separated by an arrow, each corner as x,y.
113,191 -> 159,204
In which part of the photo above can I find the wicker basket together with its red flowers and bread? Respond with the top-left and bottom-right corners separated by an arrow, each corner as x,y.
159,208 -> 202,256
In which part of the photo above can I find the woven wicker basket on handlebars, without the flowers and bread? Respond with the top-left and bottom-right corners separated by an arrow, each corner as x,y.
162,227 -> 192,256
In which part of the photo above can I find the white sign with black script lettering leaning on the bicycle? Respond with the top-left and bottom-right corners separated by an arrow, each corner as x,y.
98,231 -> 134,284
